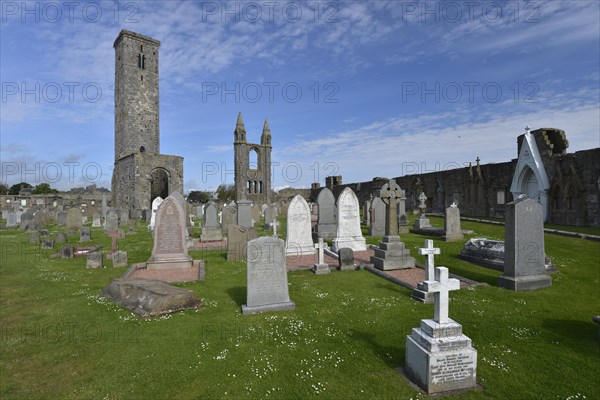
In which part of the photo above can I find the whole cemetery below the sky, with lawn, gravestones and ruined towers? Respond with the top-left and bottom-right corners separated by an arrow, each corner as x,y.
0,14 -> 600,400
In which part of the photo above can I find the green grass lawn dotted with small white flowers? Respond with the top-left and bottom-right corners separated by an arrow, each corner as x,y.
0,219 -> 600,399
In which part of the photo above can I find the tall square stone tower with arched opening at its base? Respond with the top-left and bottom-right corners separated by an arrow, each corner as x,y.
112,29 -> 183,214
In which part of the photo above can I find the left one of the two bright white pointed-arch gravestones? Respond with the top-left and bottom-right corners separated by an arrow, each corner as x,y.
285,195 -> 315,256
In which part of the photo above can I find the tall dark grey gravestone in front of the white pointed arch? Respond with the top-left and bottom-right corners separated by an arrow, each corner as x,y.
498,195 -> 552,291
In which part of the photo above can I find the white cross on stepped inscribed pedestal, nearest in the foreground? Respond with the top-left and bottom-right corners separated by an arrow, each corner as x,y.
405,267 -> 477,394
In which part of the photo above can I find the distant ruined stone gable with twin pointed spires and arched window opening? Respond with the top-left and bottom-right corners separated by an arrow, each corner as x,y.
233,113 -> 271,204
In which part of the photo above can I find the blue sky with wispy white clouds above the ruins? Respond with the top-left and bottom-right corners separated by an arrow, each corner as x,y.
0,0 -> 600,193
